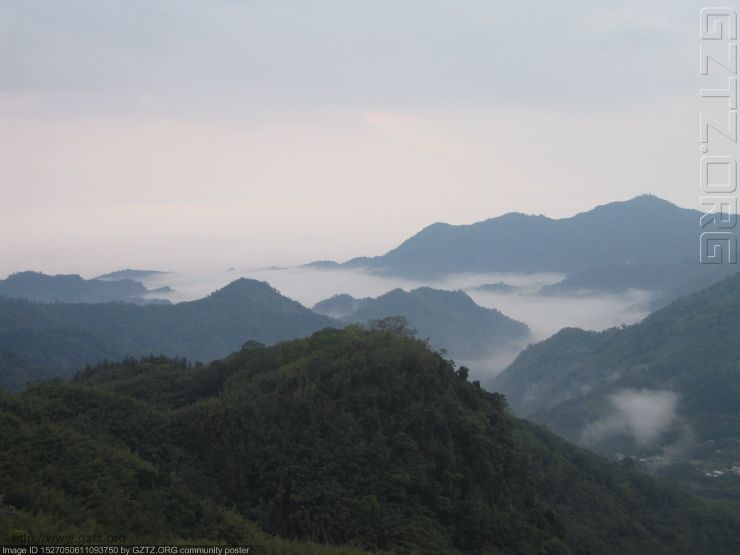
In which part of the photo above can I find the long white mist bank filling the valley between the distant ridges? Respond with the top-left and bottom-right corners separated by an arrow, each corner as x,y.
134,267 -> 651,380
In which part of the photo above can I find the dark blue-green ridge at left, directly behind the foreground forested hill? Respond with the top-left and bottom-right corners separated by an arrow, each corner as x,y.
0,279 -> 338,390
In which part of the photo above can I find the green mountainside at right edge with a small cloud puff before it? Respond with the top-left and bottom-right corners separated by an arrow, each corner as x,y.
491,275 -> 740,497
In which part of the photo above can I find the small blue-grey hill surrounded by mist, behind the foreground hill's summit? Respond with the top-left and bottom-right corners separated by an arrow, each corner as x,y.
314,287 -> 529,360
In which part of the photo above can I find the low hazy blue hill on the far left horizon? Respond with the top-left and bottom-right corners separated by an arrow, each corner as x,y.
0,272 -> 168,304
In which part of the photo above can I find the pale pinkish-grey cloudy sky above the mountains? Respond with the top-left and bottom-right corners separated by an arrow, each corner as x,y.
0,0 -> 737,276
